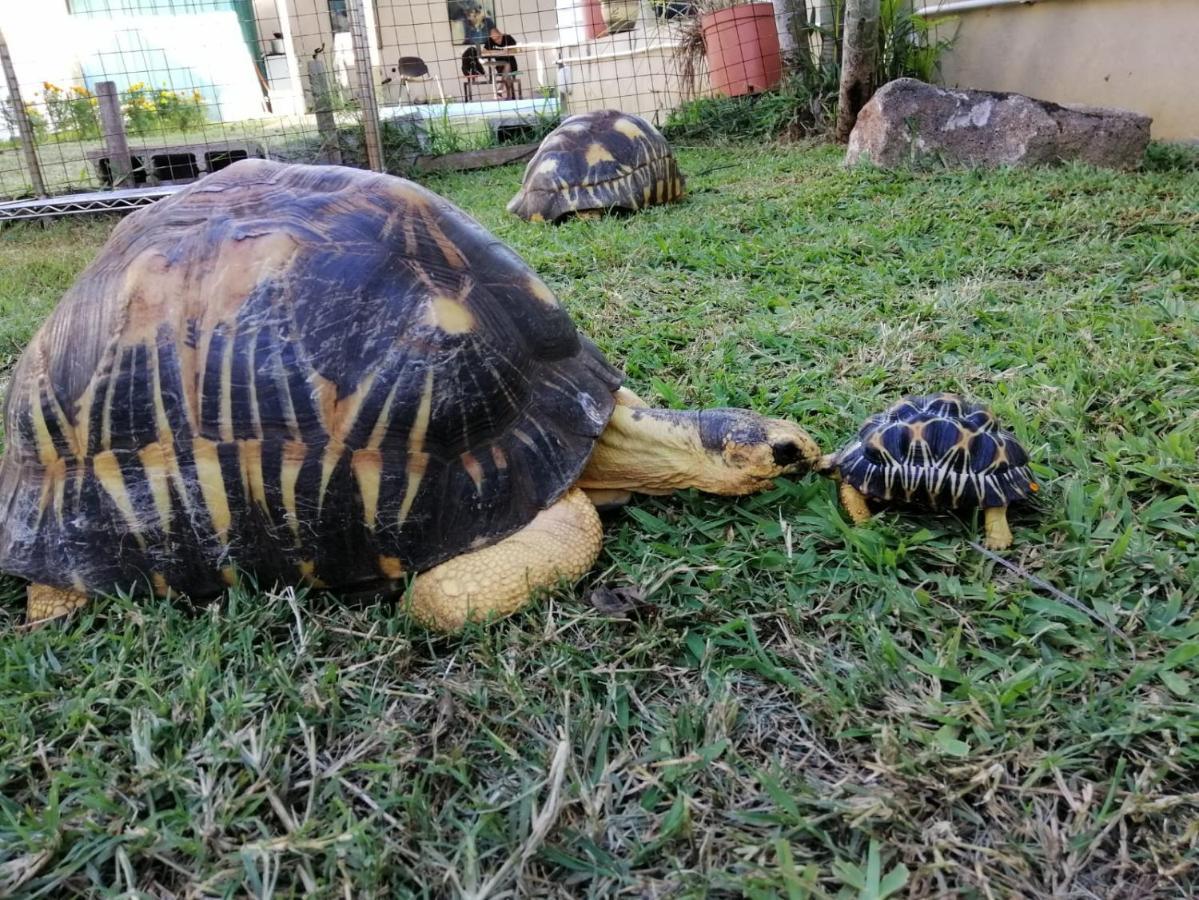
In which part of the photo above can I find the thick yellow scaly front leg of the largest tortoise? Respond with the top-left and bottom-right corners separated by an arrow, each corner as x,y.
409,488 -> 603,632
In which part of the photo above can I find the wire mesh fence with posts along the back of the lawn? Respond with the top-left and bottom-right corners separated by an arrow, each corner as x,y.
0,0 -> 839,200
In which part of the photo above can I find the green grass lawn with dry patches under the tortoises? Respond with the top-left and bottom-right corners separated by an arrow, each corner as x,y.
0,147 -> 1199,898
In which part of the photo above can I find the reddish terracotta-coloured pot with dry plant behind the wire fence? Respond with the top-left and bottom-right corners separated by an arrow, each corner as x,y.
679,0 -> 783,97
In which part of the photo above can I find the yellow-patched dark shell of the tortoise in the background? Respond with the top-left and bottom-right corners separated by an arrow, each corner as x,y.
508,109 -> 683,222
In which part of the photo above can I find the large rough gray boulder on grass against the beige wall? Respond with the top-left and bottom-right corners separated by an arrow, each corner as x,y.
845,78 -> 1153,169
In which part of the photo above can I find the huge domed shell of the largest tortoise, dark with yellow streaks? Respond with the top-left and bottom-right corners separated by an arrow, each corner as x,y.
0,161 -> 621,597
